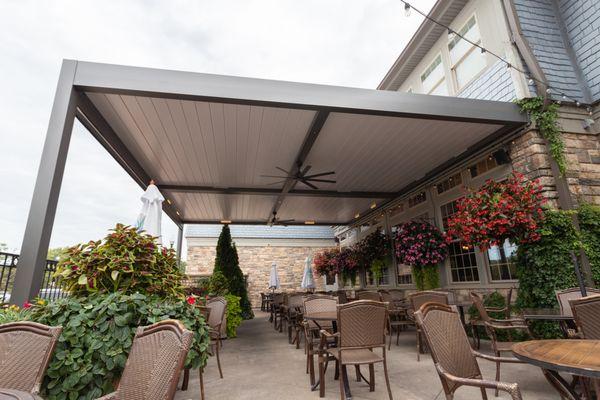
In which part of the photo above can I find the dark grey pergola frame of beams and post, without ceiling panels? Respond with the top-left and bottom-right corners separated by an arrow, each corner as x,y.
11,60 -> 528,304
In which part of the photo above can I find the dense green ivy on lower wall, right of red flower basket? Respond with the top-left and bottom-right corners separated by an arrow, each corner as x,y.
516,205 -> 600,338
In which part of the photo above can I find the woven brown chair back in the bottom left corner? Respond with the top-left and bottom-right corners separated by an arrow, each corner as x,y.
0,322 -> 62,394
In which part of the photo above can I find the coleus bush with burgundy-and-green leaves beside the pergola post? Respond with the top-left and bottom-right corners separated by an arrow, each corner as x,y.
56,224 -> 184,297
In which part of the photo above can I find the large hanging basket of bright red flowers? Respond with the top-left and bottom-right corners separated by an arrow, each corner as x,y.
447,173 -> 544,251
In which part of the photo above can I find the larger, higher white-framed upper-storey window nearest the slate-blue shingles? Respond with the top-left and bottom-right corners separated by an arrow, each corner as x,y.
448,15 -> 487,90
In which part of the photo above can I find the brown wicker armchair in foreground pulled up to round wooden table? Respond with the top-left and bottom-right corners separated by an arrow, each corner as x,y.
415,303 -> 521,400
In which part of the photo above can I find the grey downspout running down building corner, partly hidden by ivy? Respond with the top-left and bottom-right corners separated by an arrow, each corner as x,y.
502,0 -> 593,291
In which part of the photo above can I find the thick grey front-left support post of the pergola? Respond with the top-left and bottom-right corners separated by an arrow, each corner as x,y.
10,60 -> 77,306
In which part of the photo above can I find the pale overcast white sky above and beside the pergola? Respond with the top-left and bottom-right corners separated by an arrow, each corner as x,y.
0,0 -> 435,254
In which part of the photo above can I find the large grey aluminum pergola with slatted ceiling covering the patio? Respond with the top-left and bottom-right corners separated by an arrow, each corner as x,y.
11,60 -> 527,304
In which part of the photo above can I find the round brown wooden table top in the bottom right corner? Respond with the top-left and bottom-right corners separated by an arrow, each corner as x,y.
512,339 -> 600,378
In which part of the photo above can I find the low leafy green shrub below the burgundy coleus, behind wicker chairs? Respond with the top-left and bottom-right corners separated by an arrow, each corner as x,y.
29,292 -> 209,400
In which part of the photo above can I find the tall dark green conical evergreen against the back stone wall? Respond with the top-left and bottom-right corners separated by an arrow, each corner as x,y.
213,225 -> 254,319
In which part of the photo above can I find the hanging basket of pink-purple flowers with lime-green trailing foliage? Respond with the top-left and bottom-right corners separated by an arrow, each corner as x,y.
396,221 -> 448,290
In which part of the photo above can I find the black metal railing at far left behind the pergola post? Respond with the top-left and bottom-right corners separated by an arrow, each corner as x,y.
0,252 -> 67,304
